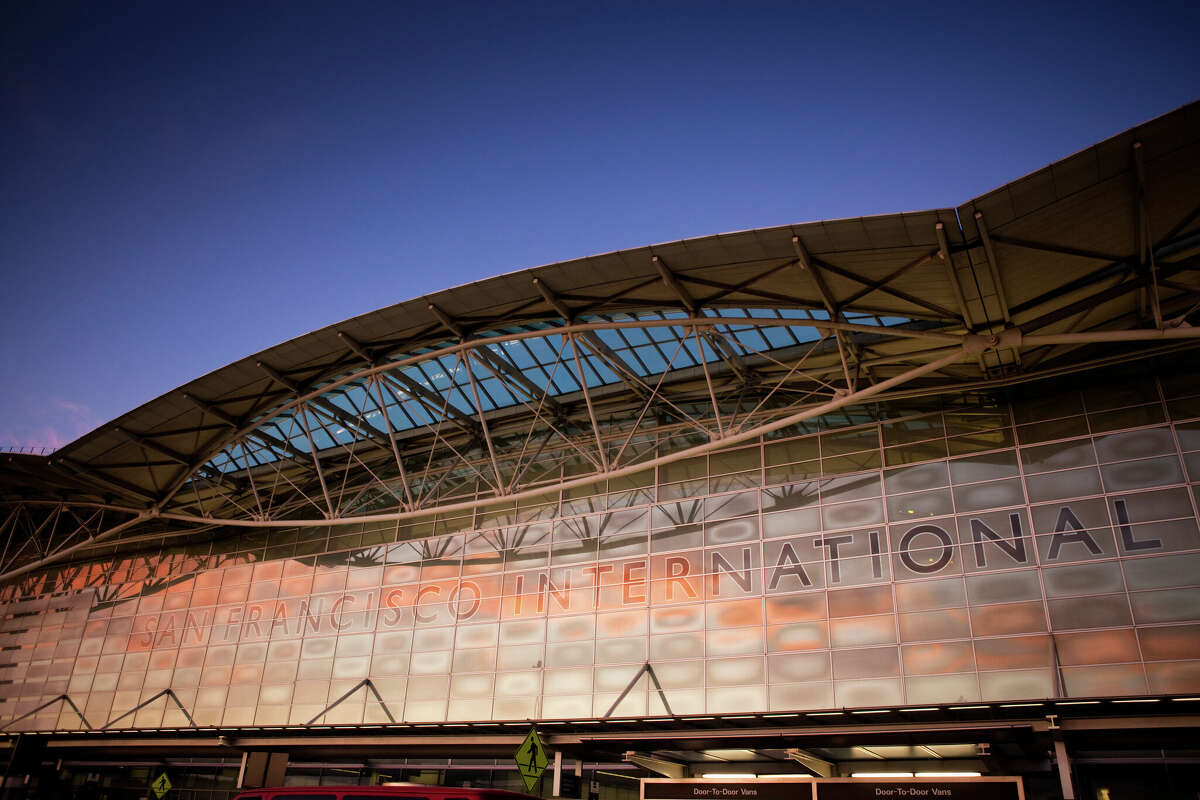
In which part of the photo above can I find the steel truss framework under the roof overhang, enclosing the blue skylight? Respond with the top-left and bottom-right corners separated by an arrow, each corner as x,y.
0,122 -> 1200,581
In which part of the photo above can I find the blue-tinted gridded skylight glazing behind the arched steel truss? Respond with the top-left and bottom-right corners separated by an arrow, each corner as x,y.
206,307 -> 911,474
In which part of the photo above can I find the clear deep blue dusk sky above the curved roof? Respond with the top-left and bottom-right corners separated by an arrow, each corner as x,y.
0,0 -> 1200,447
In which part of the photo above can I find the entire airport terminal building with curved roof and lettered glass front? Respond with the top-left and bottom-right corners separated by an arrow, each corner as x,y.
0,104 -> 1200,798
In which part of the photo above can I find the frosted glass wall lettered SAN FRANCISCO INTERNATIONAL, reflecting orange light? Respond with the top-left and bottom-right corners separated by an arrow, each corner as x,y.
7,380 -> 1200,728
